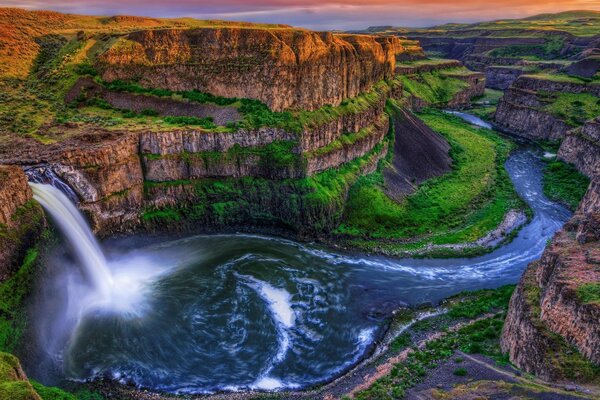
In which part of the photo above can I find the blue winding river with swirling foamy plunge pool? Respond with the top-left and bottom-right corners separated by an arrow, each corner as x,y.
26,112 -> 569,393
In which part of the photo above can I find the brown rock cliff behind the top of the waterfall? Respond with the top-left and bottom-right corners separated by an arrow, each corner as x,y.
0,132 -> 144,233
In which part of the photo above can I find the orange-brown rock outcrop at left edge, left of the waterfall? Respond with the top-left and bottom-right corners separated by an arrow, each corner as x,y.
0,166 -> 44,282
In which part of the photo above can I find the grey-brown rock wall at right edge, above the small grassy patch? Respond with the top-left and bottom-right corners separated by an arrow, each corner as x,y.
558,117 -> 600,178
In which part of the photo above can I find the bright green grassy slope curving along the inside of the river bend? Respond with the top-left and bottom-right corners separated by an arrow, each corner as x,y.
336,110 -> 523,249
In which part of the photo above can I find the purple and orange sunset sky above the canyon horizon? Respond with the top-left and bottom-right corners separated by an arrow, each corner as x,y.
0,0 -> 600,30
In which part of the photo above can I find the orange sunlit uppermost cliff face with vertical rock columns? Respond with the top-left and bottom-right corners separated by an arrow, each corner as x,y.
98,28 -> 407,111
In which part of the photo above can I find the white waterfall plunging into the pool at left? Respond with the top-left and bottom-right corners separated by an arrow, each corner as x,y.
29,182 -> 113,298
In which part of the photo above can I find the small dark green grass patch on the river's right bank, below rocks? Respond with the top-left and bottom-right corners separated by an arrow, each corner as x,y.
543,160 -> 590,211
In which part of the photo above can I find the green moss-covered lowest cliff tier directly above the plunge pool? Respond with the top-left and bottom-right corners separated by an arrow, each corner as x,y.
142,144 -> 383,233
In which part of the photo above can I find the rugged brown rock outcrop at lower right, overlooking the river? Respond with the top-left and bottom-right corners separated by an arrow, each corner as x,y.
501,180 -> 600,381
